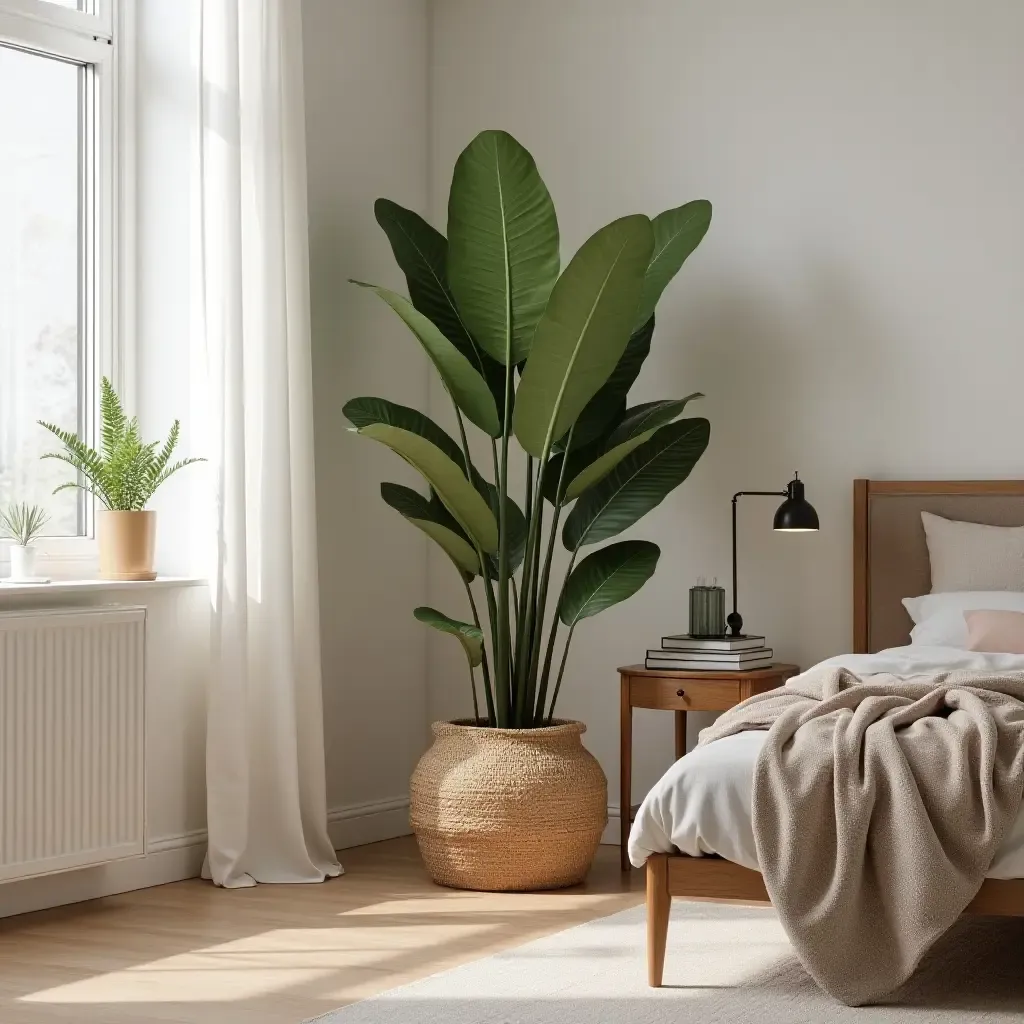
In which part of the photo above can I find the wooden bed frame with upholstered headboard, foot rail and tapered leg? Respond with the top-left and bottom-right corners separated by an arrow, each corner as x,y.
647,480 -> 1024,988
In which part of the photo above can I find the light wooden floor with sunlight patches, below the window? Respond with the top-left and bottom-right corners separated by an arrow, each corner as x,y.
0,839 -> 643,1024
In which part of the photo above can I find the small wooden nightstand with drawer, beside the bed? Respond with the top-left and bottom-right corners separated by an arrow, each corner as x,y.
618,665 -> 800,871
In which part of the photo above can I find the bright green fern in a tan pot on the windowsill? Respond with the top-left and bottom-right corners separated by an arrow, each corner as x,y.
39,377 -> 204,580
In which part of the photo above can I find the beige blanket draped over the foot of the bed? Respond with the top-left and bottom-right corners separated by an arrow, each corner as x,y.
700,668 -> 1024,1006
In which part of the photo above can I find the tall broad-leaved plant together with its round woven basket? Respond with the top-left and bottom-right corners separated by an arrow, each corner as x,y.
344,131 -> 711,890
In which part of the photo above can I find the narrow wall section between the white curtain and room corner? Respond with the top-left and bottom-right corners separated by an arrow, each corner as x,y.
302,0 -> 428,843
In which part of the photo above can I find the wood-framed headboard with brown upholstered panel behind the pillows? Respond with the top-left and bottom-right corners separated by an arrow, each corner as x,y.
853,480 -> 1024,653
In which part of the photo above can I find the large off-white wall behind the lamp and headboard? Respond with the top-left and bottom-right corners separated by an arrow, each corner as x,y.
431,0 -> 1024,801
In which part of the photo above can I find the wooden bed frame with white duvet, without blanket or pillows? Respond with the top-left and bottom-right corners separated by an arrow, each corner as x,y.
630,480 -> 1024,987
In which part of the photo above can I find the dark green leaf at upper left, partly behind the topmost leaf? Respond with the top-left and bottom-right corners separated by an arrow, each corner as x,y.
374,199 -> 505,403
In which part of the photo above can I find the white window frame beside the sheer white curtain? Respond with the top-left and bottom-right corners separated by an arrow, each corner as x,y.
0,0 -> 136,579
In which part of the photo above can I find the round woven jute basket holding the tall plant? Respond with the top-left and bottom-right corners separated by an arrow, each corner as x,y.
410,719 -> 608,892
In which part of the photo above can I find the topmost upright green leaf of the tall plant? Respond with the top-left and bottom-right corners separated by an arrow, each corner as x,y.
447,131 -> 558,366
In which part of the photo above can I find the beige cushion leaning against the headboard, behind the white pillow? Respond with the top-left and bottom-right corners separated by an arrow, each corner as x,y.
921,512 -> 1024,594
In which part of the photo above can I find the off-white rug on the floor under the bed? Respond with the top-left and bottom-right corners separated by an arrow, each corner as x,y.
307,901 -> 1024,1024
